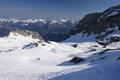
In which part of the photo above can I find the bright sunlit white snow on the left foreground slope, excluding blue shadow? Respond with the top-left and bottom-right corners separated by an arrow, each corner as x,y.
0,33 -> 79,80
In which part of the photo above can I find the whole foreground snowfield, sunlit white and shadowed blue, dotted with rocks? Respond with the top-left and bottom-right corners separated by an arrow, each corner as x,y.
0,33 -> 120,80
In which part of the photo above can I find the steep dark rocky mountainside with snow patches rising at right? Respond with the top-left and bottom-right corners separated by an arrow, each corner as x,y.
70,5 -> 120,41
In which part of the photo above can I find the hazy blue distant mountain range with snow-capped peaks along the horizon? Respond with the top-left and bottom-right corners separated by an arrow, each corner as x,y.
0,19 -> 76,41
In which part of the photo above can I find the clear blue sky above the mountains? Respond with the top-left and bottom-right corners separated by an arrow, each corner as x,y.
0,0 -> 120,20
